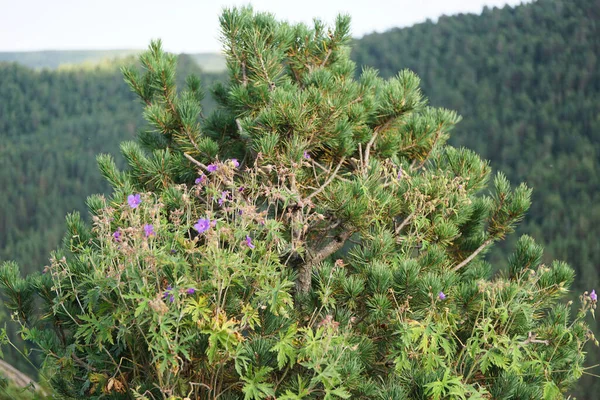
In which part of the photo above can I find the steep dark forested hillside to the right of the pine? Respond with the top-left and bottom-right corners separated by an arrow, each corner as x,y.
352,0 -> 600,398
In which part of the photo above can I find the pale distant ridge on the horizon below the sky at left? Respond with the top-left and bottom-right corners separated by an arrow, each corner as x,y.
0,49 -> 226,73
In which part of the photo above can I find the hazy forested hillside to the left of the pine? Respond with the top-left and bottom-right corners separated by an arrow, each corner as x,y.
0,57 -> 225,271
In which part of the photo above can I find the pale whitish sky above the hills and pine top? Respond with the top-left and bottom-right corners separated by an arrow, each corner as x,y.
0,0 -> 528,53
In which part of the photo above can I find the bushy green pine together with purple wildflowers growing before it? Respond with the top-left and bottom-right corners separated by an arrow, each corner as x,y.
0,8 -> 597,400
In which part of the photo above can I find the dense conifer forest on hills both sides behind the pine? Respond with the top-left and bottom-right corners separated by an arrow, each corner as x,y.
0,0 -> 600,399
